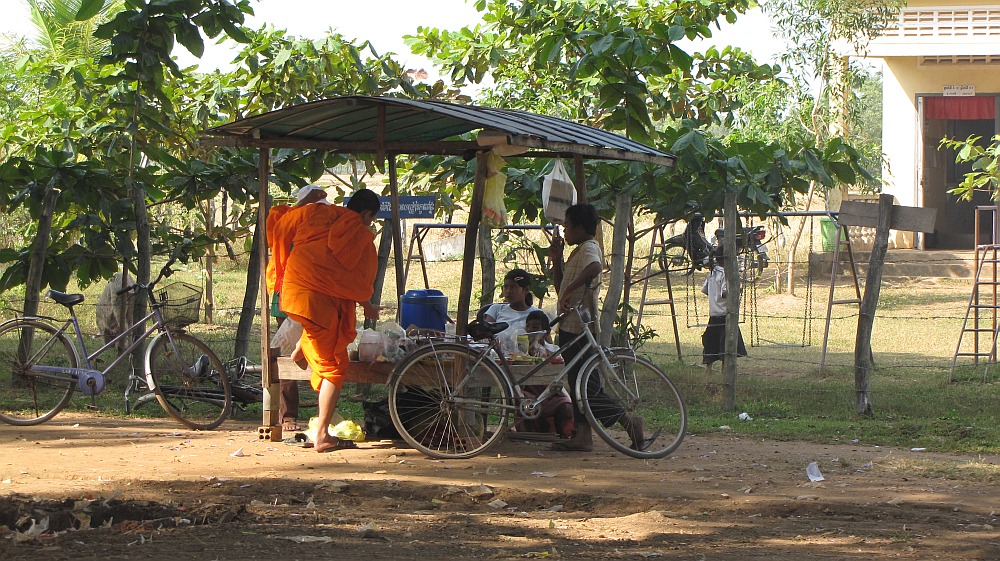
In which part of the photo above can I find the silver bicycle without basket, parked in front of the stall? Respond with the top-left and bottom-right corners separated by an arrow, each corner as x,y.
388,307 -> 687,459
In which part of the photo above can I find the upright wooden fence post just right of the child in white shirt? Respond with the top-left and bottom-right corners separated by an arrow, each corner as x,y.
722,193 -> 743,411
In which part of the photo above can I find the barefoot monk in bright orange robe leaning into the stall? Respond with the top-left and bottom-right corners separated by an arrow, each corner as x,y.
268,189 -> 379,452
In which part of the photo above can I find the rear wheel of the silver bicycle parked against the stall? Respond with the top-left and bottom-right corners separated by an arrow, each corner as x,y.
389,343 -> 513,459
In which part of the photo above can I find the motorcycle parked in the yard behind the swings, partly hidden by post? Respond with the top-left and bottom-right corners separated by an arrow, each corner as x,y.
660,213 -> 769,282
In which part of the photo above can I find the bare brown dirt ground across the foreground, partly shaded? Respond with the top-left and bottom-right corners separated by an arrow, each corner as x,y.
0,414 -> 1000,561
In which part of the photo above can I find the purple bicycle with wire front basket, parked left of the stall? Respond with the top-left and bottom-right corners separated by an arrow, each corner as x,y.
0,250 -> 232,430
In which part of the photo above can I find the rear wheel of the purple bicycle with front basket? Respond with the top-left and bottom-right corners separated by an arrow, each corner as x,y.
0,319 -> 77,426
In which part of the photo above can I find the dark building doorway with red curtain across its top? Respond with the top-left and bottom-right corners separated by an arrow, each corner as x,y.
920,95 -> 998,249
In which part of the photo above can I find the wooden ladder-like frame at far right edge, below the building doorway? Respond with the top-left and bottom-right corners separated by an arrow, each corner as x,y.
948,245 -> 1000,382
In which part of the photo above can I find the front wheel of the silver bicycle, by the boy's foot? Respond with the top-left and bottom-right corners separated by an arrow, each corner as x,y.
575,349 -> 687,458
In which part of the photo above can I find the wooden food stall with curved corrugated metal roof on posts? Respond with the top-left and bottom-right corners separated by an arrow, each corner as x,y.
202,96 -> 676,438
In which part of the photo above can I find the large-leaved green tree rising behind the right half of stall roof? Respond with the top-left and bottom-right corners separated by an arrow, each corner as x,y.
408,0 -> 857,342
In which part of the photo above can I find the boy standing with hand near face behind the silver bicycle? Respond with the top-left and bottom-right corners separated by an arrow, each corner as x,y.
549,203 -> 650,452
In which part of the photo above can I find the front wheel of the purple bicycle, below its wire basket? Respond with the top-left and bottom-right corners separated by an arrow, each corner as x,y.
146,332 -> 232,430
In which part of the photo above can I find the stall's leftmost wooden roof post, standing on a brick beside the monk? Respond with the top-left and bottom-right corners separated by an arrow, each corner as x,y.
257,148 -> 281,426
